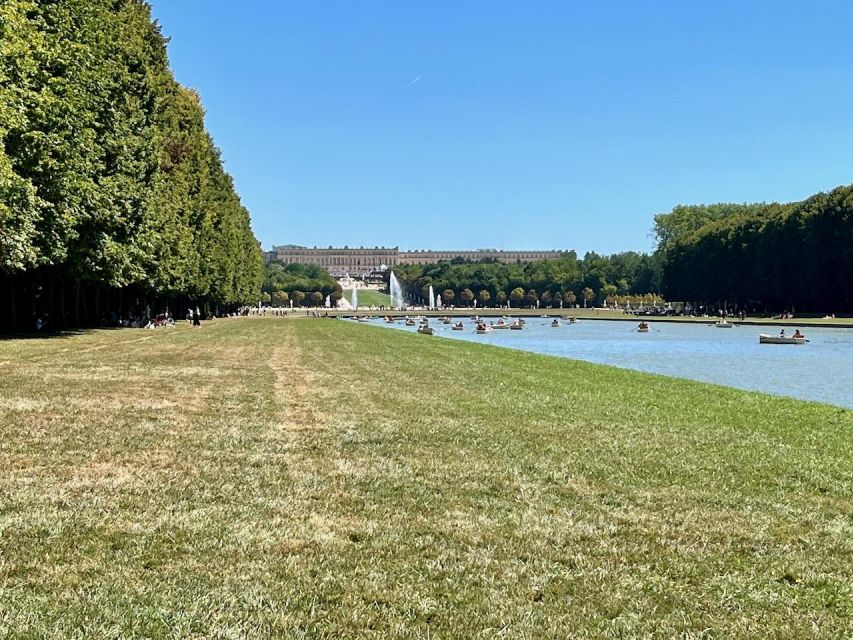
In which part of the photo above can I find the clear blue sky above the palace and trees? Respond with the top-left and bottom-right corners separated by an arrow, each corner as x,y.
152,0 -> 853,254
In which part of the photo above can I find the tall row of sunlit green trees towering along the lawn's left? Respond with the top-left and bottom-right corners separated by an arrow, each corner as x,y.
0,0 -> 263,329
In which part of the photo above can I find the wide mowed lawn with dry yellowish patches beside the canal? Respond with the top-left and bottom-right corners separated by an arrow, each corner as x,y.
0,318 -> 853,638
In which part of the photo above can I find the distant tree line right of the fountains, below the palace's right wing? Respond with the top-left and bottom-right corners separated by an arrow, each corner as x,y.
394,251 -> 660,307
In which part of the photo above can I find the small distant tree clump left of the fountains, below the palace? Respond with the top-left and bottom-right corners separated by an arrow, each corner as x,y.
262,260 -> 343,307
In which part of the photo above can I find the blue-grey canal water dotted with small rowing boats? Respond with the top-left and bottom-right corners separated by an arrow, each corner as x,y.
373,318 -> 853,409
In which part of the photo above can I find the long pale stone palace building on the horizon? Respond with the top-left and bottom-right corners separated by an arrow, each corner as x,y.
264,244 -> 562,276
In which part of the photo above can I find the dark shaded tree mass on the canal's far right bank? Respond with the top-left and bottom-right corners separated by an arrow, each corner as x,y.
656,186 -> 853,313
